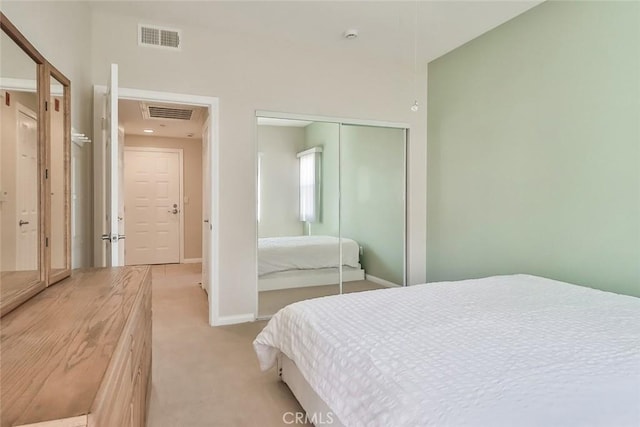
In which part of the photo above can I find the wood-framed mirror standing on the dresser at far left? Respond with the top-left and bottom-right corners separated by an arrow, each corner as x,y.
0,12 -> 71,316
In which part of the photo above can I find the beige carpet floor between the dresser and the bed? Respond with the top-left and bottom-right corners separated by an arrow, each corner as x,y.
147,264 -> 310,427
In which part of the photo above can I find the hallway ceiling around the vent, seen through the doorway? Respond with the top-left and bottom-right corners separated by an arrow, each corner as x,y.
118,99 -> 207,139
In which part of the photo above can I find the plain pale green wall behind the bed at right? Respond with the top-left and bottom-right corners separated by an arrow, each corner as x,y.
427,1 -> 640,296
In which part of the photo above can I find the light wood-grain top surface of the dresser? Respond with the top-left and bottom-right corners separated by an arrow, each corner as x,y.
0,266 -> 151,426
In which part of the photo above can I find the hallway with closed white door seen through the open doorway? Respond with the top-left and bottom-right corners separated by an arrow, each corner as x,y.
118,99 -> 208,268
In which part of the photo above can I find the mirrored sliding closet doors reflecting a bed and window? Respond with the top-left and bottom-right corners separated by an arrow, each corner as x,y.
257,116 -> 405,317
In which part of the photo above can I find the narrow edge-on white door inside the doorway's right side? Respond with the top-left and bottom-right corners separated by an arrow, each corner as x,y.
202,119 -> 212,293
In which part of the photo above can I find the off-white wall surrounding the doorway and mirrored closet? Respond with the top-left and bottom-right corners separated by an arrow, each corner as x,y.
3,2 -> 426,316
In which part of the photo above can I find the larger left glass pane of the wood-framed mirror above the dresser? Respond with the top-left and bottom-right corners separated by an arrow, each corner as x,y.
0,28 -> 42,312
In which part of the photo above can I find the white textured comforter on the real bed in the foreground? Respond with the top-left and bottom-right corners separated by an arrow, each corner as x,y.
254,275 -> 640,427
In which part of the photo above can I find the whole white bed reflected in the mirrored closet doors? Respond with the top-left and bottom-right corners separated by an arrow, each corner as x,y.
258,236 -> 364,291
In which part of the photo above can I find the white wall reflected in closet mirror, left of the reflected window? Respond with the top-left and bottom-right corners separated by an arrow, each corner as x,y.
258,126 -> 304,237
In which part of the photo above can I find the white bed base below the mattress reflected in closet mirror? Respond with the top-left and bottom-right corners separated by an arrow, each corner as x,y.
258,266 -> 365,291
